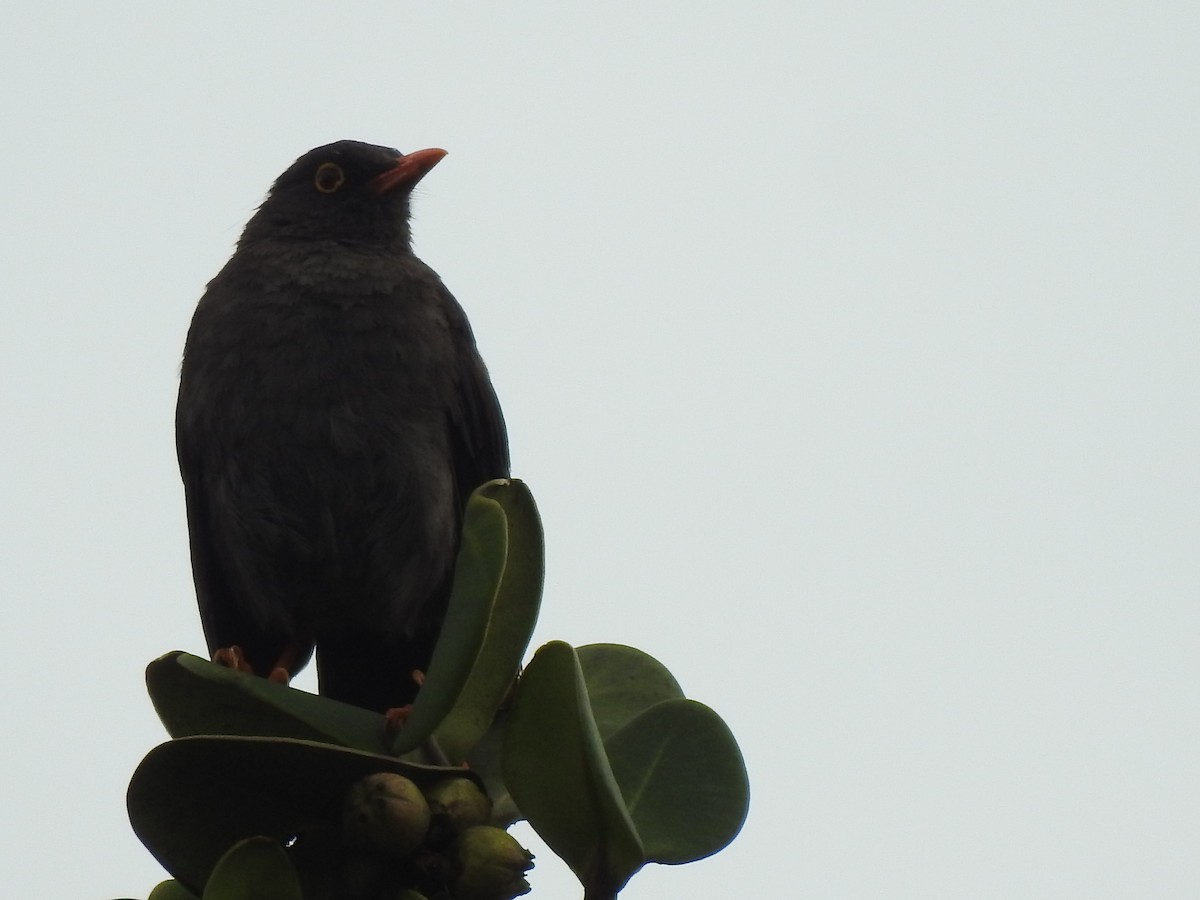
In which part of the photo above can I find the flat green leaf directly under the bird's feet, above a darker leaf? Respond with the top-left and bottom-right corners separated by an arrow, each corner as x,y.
146,650 -> 388,752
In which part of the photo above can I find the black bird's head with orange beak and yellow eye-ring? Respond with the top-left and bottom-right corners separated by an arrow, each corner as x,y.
241,140 -> 446,250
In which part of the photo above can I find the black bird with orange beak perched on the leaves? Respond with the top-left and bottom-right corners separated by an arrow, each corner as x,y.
175,140 -> 509,712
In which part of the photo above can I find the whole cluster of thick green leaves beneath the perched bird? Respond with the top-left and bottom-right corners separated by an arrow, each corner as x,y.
119,480 -> 749,900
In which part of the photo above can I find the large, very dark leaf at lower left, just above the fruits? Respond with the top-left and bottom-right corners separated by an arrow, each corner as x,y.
126,736 -> 478,895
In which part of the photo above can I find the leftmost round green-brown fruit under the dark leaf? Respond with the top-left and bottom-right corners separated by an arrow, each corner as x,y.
342,772 -> 430,857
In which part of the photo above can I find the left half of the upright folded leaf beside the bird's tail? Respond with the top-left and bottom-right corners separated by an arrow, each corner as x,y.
391,482 -> 509,756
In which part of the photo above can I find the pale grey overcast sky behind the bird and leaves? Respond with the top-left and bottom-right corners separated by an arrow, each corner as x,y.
0,1 -> 1200,900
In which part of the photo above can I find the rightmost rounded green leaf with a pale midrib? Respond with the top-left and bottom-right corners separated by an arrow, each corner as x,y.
606,700 -> 750,865
